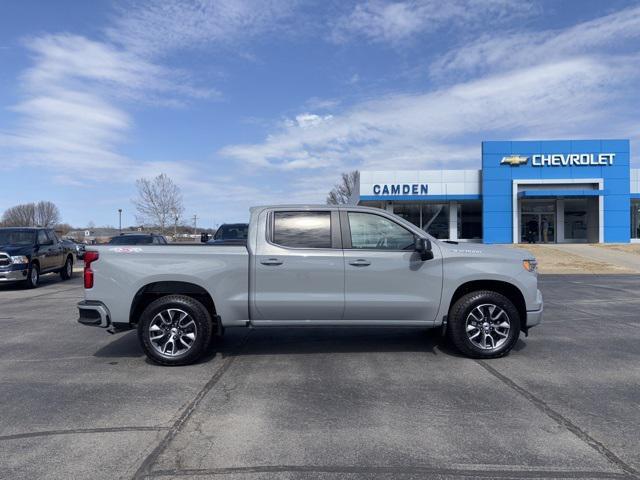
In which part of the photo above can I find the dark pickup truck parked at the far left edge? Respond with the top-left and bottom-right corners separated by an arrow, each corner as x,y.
0,227 -> 75,288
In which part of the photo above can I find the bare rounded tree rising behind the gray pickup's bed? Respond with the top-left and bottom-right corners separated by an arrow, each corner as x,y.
133,173 -> 184,234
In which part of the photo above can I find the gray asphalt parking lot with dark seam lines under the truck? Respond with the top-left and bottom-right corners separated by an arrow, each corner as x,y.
0,275 -> 640,479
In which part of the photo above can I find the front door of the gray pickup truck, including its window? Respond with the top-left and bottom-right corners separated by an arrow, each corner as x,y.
341,211 -> 442,322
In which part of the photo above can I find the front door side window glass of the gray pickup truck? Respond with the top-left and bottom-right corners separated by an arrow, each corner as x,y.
349,212 -> 415,250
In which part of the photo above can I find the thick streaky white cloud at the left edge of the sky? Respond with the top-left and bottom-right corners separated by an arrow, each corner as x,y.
0,34 -> 206,176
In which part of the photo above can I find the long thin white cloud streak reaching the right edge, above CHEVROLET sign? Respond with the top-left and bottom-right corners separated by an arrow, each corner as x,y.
430,6 -> 640,80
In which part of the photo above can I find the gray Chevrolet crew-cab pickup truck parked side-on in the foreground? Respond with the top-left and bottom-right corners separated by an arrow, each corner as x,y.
78,206 -> 543,365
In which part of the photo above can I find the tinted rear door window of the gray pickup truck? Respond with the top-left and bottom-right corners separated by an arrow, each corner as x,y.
272,211 -> 331,248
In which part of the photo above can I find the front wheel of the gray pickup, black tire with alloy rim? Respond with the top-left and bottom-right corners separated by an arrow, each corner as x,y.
447,290 -> 520,358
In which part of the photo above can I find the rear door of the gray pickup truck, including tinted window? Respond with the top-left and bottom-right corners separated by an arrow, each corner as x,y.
254,209 -> 344,321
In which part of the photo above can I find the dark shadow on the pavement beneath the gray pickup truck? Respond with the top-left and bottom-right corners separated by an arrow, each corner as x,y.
94,327 -> 526,363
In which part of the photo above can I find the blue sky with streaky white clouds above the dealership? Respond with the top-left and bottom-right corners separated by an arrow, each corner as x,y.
0,0 -> 640,226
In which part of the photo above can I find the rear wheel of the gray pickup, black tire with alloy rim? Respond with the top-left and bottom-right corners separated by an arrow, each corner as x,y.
138,295 -> 212,366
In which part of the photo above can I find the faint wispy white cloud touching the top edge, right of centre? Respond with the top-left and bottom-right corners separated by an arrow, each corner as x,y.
330,0 -> 532,44
